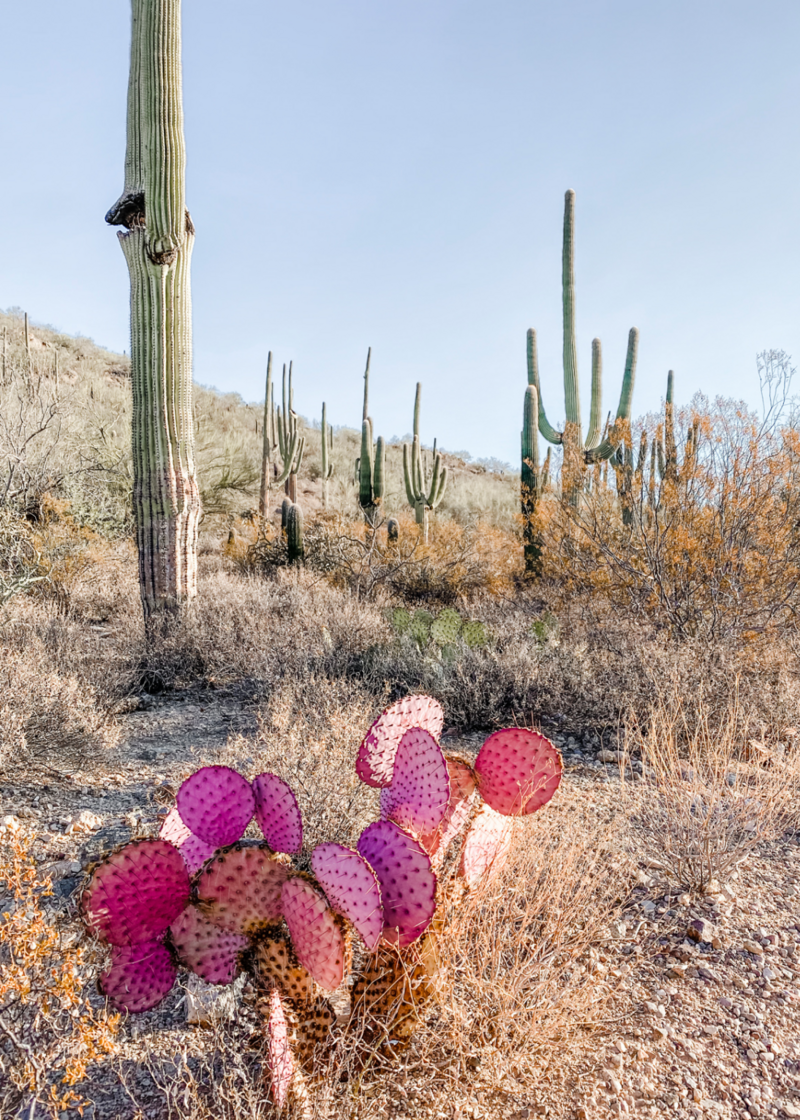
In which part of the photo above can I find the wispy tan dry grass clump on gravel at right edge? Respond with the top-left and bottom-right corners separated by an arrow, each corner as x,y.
623,692 -> 800,892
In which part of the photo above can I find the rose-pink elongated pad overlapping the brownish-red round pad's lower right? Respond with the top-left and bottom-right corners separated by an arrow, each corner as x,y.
280,878 -> 345,991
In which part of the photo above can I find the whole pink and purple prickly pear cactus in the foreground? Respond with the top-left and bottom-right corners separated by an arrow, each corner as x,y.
81,696 -> 561,1108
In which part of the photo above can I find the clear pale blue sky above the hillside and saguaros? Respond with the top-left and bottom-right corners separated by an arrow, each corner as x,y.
0,0 -> 800,461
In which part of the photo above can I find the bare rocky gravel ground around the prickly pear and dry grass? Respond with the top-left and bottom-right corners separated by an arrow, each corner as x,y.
0,689 -> 800,1120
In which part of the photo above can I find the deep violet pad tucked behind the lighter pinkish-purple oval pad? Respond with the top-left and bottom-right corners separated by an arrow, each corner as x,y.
359,821 -> 436,949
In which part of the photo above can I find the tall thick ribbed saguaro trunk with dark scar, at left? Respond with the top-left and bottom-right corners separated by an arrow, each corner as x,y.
105,0 -> 201,620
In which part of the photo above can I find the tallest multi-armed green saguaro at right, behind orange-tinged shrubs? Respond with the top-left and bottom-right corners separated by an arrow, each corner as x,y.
528,190 -> 639,505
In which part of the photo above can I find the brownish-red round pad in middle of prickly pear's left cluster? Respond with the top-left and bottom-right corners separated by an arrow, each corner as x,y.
197,844 -> 291,934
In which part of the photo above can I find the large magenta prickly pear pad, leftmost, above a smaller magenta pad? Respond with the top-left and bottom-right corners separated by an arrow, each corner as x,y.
81,840 -> 189,945
